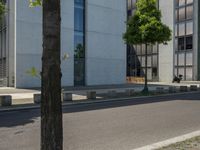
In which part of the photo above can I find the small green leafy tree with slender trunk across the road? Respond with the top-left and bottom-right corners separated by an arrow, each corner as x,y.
123,0 -> 171,93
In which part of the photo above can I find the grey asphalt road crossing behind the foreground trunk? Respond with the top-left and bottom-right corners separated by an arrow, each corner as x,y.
0,93 -> 200,150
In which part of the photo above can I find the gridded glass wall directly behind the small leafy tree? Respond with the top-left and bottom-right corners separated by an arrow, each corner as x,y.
127,0 -> 158,81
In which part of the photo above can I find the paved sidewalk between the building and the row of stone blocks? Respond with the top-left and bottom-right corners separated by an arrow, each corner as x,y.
0,82 -> 200,108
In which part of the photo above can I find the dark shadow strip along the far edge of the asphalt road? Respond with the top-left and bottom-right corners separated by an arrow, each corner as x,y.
0,93 -> 200,128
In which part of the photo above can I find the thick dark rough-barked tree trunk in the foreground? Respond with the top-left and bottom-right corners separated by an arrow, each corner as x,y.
41,0 -> 63,150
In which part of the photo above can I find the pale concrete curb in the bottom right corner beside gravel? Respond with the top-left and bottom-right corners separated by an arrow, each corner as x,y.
132,130 -> 200,150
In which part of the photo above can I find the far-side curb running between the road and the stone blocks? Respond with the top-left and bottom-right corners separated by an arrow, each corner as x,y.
0,91 -> 199,112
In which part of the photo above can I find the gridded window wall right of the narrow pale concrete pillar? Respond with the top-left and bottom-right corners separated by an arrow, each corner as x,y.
174,0 -> 193,80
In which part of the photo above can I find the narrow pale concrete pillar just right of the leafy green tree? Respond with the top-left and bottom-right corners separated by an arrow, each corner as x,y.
158,0 -> 175,82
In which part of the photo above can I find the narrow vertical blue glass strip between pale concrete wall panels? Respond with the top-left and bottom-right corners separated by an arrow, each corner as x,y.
74,0 -> 85,86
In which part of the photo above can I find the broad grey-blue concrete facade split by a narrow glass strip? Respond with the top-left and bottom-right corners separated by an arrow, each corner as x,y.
6,0 -> 126,87
